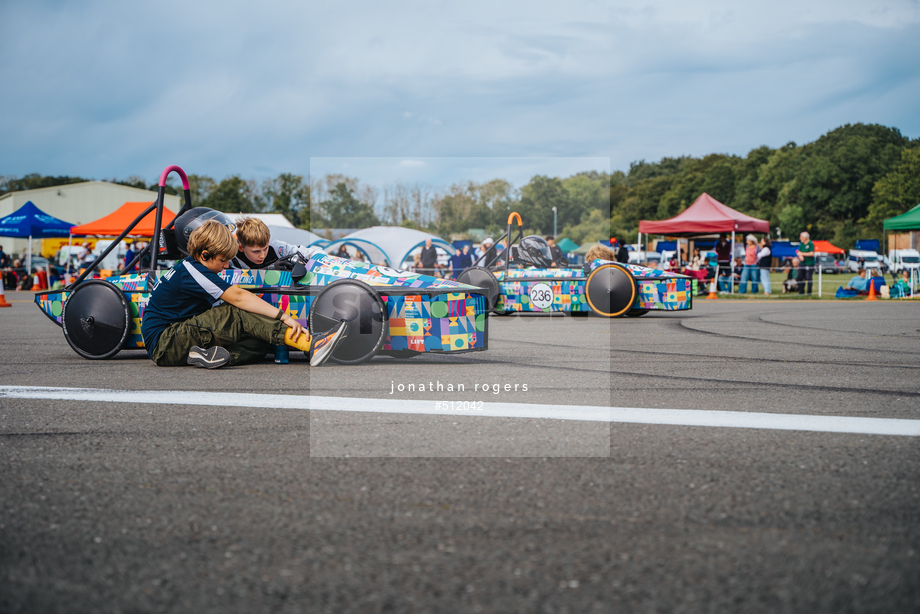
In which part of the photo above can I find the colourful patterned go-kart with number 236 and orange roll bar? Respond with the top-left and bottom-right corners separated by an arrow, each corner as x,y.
457,213 -> 693,318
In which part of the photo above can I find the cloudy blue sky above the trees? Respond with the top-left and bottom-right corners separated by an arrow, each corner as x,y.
0,0 -> 920,192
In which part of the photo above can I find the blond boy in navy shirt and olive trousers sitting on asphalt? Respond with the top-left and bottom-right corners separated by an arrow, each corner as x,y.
141,220 -> 347,369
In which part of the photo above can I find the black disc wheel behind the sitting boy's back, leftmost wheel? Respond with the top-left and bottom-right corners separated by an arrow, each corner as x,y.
62,279 -> 131,360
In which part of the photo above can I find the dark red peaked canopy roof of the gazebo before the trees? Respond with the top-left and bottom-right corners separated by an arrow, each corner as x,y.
639,192 -> 770,237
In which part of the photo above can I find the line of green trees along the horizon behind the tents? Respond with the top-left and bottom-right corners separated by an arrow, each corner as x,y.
0,124 -> 920,249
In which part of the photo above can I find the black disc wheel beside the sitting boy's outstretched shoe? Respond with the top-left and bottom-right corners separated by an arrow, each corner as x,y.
310,279 -> 389,365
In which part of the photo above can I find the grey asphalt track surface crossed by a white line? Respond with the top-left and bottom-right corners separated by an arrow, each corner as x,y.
0,292 -> 920,612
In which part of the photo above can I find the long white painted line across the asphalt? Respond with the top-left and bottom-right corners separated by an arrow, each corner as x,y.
0,386 -> 920,437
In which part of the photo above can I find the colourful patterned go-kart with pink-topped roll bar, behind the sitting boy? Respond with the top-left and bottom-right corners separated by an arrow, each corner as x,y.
35,166 -> 488,364
